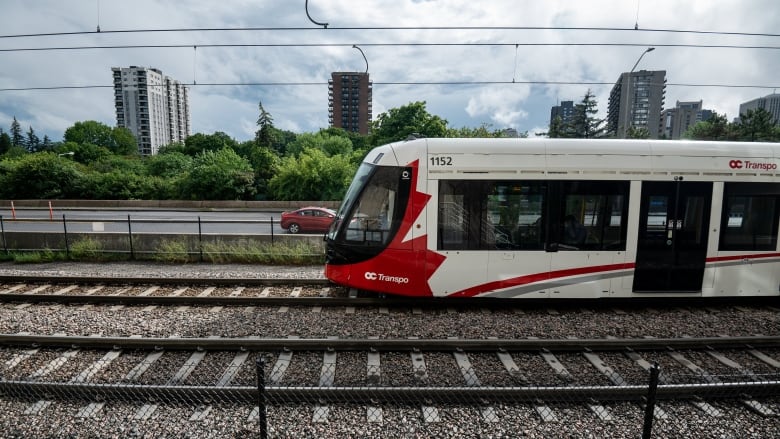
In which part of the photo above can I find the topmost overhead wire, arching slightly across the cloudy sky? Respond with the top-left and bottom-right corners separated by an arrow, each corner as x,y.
0,26 -> 780,39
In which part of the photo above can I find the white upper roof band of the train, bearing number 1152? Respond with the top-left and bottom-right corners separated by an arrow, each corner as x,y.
366,138 -> 780,181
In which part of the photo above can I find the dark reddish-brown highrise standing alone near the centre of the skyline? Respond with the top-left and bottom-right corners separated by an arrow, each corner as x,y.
328,72 -> 373,134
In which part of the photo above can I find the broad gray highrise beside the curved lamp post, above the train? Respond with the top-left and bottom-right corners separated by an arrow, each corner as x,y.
607,70 -> 666,139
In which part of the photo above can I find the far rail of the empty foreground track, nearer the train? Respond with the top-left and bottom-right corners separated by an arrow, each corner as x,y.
0,334 -> 780,352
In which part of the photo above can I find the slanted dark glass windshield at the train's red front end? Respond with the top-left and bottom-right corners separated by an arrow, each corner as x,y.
328,163 -> 411,247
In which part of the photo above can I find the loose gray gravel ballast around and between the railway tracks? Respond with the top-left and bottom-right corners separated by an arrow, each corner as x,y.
0,263 -> 780,439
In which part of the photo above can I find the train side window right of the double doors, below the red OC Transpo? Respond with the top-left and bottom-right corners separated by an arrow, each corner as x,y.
719,183 -> 780,250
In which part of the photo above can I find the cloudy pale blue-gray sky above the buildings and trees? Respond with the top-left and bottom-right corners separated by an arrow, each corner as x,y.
0,0 -> 780,140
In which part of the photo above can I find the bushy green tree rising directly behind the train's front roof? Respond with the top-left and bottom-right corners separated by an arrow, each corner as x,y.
371,101 -> 447,145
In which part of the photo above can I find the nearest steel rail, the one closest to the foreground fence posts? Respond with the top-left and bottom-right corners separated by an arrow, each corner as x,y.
0,380 -> 780,405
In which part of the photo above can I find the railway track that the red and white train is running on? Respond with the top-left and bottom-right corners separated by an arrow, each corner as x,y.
0,275 -> 780,309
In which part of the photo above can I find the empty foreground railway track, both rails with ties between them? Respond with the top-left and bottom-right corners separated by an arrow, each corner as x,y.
0,334 -> 780,436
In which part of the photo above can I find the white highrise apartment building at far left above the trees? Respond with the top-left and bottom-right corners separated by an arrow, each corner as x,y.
111,66 -> 190,155
